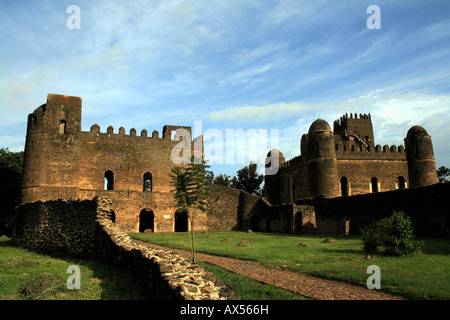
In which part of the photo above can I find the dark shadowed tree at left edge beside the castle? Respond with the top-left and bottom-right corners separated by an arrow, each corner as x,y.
0,148 -> 23,237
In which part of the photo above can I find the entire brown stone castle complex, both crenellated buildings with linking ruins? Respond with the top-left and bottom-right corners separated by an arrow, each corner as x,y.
22,94 -> 438,232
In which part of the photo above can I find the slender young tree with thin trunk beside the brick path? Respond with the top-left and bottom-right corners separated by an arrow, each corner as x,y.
170,156 -> 209,263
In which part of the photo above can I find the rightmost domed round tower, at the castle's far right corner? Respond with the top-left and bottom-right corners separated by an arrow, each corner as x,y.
405,126 -> 438,187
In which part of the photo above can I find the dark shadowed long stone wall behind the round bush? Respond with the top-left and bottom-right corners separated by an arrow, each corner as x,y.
314,183 -> 450,237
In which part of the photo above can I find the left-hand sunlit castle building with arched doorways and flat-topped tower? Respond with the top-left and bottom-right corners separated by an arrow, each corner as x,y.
22,94 -> 203,232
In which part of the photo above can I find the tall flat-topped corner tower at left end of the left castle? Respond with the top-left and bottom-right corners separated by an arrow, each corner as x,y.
22,94 -> 81,202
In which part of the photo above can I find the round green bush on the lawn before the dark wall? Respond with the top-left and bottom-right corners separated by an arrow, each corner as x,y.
362,211 -> 423,257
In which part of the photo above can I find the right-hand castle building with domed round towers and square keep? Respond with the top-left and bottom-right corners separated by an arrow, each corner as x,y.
265,114 -> 438,204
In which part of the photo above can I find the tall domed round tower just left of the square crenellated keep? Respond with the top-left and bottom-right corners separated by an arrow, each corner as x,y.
305,119 -> 339,198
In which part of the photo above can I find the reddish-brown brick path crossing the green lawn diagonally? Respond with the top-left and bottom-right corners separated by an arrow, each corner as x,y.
135,240 -> 404,300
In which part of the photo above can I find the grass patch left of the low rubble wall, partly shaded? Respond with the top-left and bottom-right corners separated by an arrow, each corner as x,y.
0,236 -> 147,300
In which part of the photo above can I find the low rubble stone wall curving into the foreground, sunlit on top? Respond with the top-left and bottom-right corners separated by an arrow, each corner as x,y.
12,198 -> 235,300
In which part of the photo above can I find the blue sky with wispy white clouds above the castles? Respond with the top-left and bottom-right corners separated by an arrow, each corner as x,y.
0,0 -> 450,175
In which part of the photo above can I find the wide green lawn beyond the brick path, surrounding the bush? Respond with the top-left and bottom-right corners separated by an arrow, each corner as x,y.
130,231 -> 450,300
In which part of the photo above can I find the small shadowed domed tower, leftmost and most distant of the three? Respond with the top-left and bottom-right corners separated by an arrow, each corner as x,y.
264,149 -> 285,203
